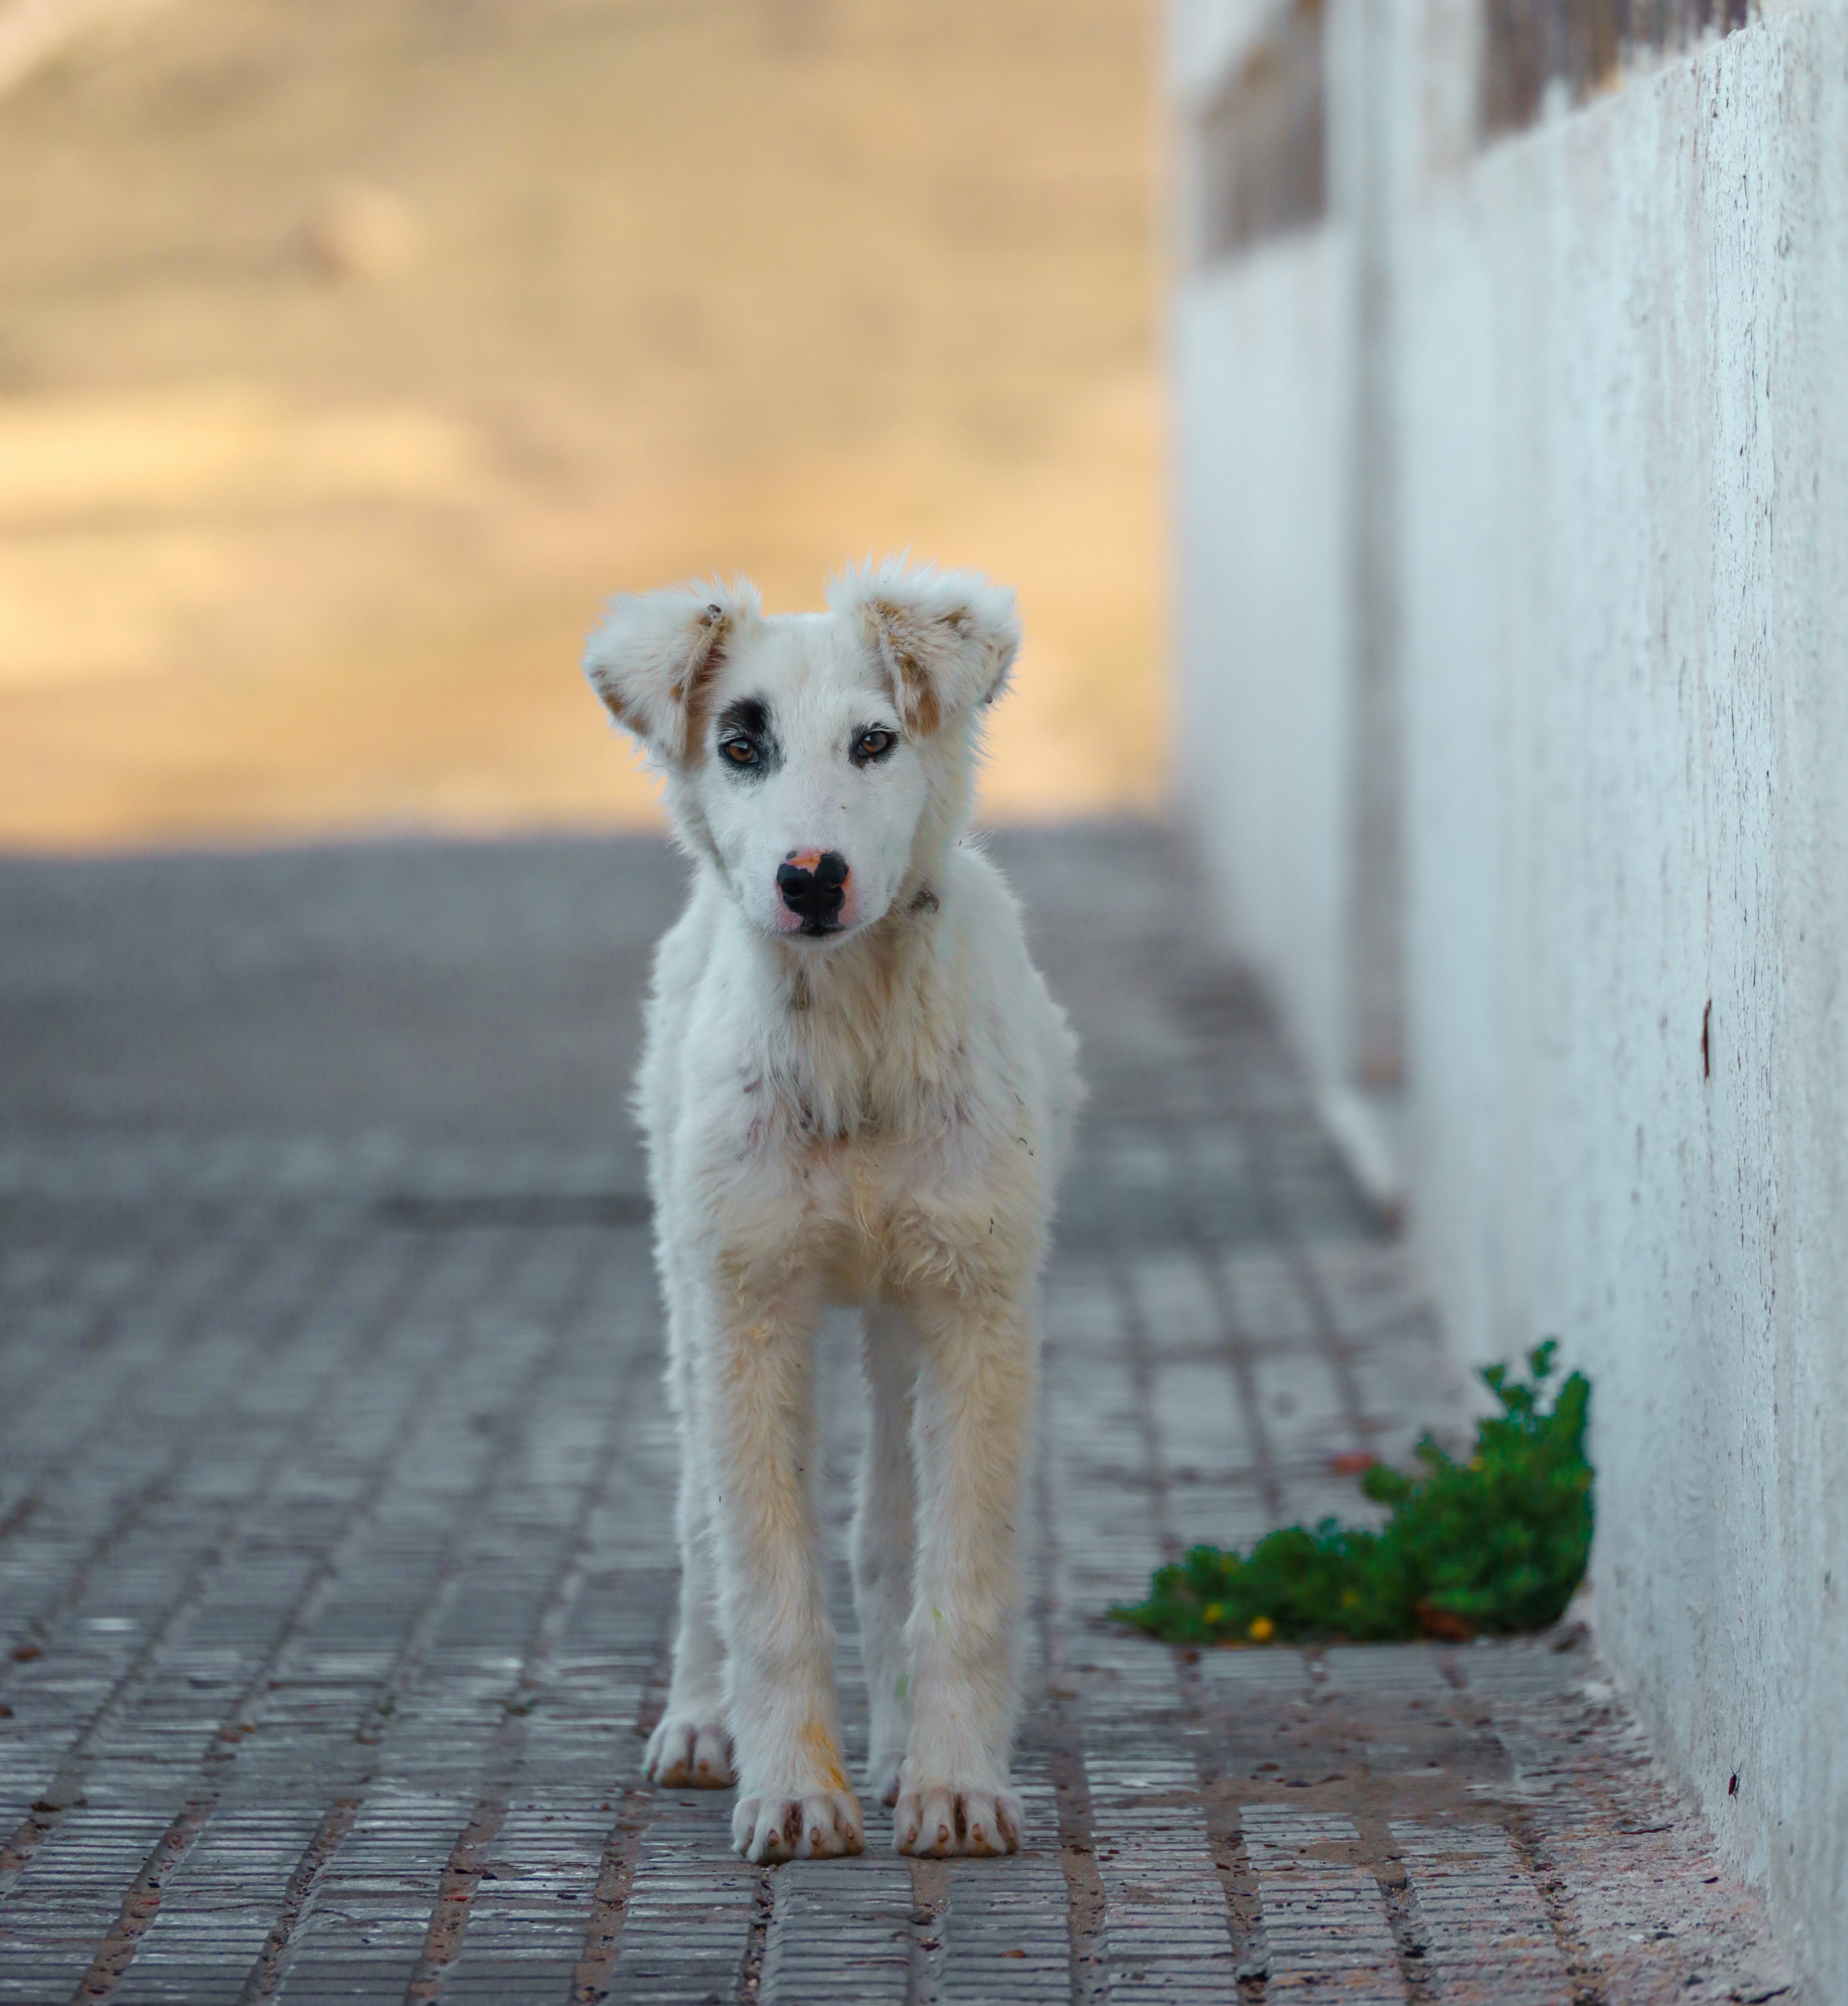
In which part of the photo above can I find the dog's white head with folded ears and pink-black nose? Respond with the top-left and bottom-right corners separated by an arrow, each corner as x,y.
584,558 -> 1020,943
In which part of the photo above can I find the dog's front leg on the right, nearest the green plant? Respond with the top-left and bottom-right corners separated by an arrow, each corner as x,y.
893,1296 -> 1035,1854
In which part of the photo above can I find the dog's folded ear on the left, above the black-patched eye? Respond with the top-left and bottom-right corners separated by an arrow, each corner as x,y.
584,578 -> 762,766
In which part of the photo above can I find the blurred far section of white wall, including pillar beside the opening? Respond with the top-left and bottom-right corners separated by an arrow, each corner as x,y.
1170,0 -> 1404,1089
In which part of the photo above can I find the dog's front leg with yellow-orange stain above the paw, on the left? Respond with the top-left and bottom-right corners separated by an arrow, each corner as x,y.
700,1280 -> 863,1862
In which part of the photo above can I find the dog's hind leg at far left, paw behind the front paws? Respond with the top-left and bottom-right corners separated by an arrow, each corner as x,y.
646,1304 -> 733,1789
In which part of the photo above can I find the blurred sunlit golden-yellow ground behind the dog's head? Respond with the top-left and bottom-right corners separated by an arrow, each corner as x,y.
0,0 -> 1168,849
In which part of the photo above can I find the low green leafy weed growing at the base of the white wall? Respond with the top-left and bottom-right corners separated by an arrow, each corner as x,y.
1110,1340 -> 1591,1643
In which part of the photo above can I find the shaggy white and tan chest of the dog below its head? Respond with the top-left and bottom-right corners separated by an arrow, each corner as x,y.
650,862 -> 1049,1298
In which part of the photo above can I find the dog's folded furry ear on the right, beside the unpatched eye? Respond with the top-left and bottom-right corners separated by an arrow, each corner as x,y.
827,558 -> 1020,738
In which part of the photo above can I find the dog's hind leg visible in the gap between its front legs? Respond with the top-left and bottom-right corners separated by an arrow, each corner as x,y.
853,1304 -> 917,1803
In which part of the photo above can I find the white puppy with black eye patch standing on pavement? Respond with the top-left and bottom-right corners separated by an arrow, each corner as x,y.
586,560 -> 1082,1860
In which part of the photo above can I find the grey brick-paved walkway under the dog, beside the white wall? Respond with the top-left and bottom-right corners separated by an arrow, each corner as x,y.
0,829 -> 1794,2006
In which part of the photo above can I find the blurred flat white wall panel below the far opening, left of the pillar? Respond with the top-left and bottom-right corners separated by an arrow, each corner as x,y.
1172,227 -> 1353,1075
